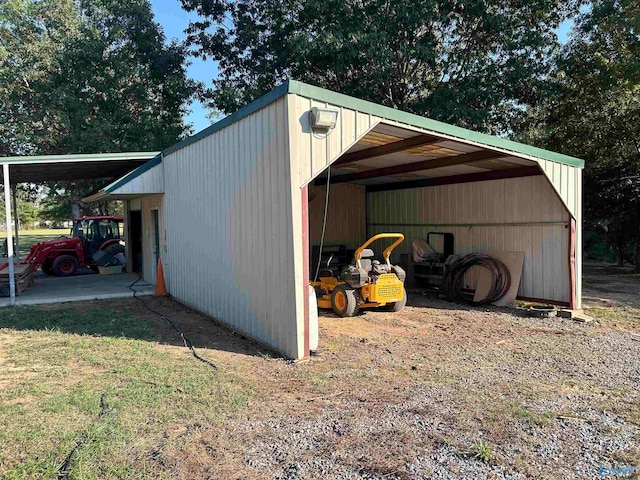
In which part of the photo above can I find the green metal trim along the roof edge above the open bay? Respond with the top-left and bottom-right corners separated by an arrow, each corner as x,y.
288,80 -> 584,168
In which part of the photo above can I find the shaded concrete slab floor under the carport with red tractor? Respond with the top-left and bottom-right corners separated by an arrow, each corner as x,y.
0,270 -> 155,307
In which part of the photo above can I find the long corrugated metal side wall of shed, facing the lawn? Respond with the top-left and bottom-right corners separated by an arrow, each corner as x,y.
163,96 -> 304,358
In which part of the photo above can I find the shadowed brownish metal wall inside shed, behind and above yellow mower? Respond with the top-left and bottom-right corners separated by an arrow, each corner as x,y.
309,183 -> 367,249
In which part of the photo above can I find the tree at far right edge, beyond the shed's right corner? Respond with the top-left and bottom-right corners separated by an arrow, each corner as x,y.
524,0 -> 640,272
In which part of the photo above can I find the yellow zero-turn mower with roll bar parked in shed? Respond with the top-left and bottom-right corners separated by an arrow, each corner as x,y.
311,233 -> 407,317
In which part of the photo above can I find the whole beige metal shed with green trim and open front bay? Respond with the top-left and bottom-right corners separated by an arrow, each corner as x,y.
55,81 -> 584,358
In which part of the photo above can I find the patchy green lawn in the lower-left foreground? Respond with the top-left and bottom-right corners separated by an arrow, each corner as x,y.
0,307 -> 249,480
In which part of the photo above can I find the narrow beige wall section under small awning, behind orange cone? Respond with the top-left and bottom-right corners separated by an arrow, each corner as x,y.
140,195 -> 167,283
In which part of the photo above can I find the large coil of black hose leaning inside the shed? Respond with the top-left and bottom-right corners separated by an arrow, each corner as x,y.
442,253 -> 511,305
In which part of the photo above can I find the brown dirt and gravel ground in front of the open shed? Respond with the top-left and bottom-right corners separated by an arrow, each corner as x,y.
104,268 -> 640,479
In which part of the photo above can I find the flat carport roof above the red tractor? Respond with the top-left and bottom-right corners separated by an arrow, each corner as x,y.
0,152 -> 159,184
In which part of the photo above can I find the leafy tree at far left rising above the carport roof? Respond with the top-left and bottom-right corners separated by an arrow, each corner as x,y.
0,0 -> 198,217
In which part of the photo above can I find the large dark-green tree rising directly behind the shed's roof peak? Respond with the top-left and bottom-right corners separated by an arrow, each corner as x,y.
182,0 -> 576,133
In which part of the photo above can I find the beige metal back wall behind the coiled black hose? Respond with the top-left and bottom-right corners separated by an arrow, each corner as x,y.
368,175 -> 570,302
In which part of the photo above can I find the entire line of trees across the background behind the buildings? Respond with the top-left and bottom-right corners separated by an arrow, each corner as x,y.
0,0 -> 640,270
